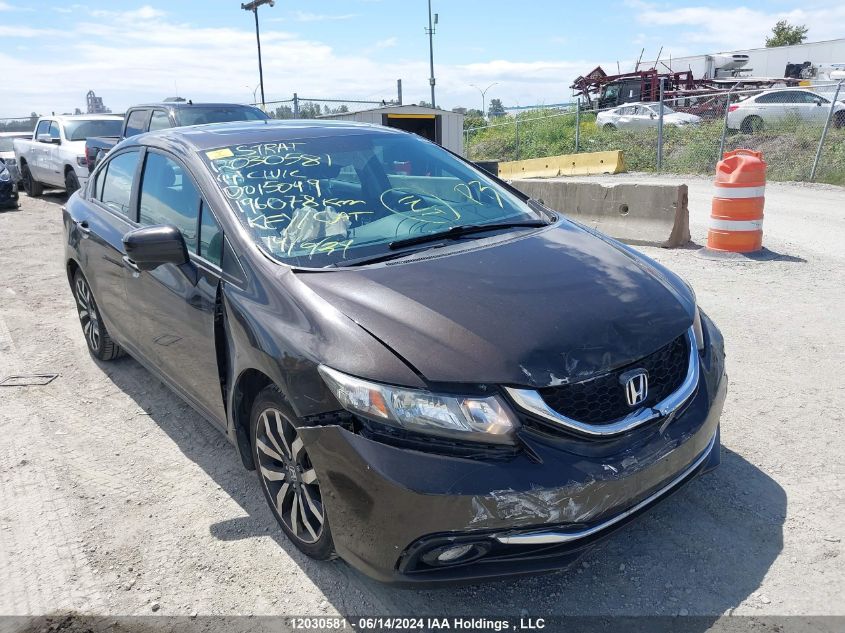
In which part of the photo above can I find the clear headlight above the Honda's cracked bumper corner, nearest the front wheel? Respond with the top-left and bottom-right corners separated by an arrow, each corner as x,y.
320,365 -> 517,444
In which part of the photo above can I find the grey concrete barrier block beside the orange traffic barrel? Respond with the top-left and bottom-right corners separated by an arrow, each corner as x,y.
512,179 -> 690,248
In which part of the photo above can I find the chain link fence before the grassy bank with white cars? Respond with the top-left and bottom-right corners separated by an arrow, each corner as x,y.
464,82 -> 845,185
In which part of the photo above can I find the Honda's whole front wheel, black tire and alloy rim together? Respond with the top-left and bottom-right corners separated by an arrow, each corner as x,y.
250,386 -> 334,560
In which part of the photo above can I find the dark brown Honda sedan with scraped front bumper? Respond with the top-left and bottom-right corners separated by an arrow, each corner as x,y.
64,121 -> 727,584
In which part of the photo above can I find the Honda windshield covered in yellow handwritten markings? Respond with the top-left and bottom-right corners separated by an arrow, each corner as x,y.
202,130 -> 538,267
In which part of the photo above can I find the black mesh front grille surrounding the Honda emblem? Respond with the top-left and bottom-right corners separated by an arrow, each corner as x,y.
537,334 -> 689,425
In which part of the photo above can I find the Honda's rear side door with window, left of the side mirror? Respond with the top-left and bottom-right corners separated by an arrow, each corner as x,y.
74,147 -> 141,336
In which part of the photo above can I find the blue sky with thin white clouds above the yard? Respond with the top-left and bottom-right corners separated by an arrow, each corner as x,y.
0,0 -> 845,118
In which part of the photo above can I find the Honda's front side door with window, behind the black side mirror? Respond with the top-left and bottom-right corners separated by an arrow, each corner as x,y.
126,149 -> 226,424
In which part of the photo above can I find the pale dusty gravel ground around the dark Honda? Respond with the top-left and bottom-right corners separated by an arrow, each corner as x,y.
0,175 -> 845,616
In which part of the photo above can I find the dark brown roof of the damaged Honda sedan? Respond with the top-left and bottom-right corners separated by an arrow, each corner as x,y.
132,119 -> 407,152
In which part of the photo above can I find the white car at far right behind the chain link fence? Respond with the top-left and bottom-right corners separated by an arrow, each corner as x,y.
728,88 -> 845,134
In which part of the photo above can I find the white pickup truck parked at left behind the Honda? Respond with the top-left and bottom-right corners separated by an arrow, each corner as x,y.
14,114 -> 123,196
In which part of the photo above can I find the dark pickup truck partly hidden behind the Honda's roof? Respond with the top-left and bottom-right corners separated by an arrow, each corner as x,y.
85,101 -> 270,172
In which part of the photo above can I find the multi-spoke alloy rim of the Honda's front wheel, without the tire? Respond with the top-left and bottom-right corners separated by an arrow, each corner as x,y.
255,408 -> 325,543
